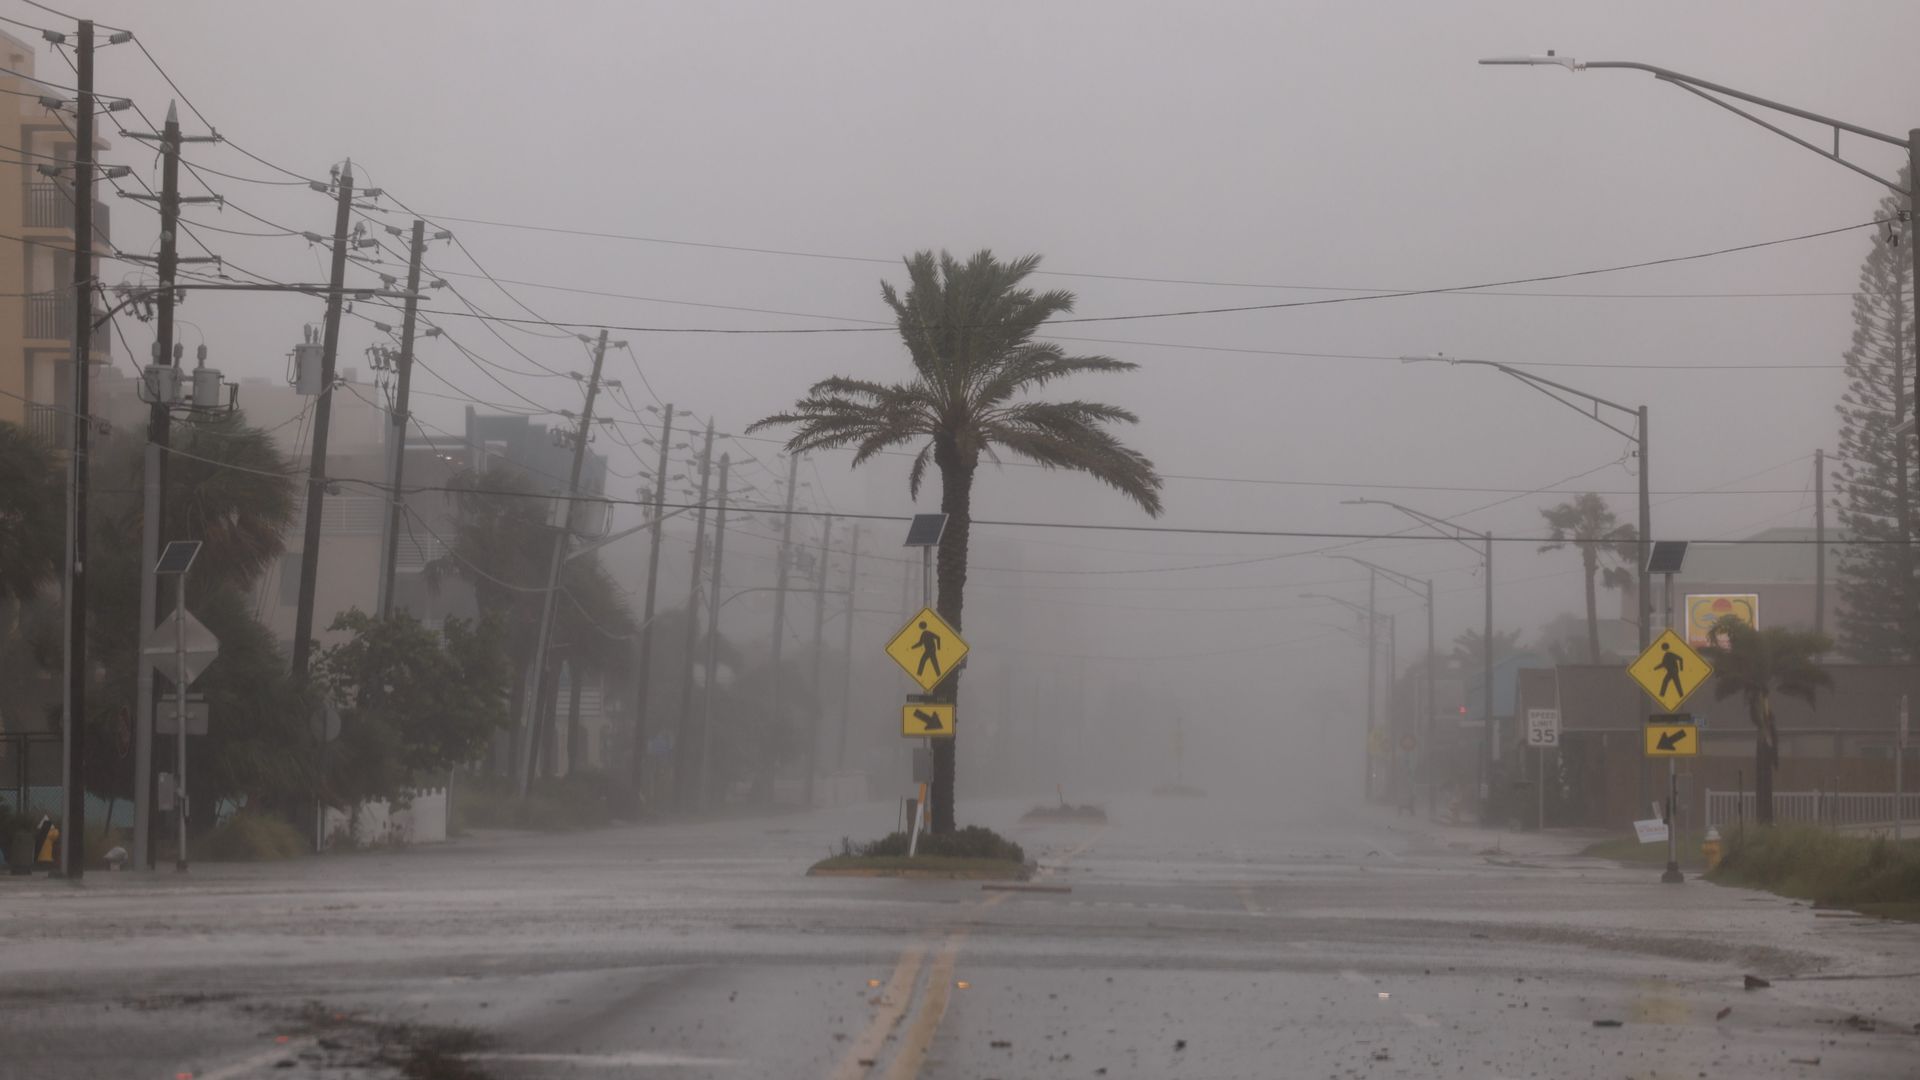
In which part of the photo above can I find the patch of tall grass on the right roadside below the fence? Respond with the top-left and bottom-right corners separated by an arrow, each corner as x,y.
1707,824 -> 1920,919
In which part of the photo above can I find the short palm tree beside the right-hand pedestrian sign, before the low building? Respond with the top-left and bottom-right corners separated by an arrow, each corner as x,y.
1701,615 -> 1834,824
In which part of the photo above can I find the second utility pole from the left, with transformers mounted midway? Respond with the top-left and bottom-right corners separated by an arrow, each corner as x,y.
127,102 -> 219,871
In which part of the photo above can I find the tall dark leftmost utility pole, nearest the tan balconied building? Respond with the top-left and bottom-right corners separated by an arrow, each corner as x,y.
60,19 -> 94,880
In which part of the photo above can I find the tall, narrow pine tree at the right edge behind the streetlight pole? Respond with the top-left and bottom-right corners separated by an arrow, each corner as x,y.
1834,163 -> 1920,663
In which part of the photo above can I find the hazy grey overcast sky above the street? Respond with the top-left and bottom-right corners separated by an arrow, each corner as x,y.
41,0 -> 1920,757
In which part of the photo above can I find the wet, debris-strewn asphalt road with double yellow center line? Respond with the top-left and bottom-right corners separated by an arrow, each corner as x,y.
0,796 -> 1920,1080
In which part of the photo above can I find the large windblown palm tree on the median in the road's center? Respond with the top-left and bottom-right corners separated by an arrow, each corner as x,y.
749,252 -> 1160,832
